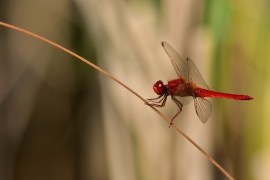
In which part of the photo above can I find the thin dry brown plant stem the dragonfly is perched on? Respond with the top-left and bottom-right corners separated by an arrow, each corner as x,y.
0,21 -> 234,180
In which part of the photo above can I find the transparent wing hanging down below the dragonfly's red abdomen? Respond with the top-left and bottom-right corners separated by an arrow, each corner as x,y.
194,97 -> 212,123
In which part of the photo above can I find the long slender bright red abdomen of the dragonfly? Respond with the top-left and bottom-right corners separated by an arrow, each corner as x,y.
194,88 -> 253,100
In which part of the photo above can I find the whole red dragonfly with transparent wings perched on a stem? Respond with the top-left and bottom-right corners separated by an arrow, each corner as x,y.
147,42 -> 253,124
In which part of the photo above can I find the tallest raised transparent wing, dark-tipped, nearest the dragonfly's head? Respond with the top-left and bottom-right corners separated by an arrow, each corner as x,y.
161,41 -> 188,81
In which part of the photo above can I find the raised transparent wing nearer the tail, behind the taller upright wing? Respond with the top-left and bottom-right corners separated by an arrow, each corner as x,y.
187,58 -> 209,89
